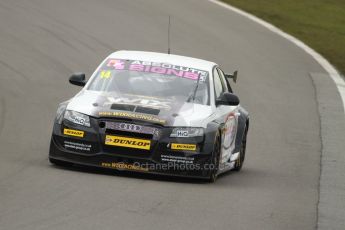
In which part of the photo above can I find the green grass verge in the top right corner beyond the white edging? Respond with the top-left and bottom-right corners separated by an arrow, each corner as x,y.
223,0 -> 345,74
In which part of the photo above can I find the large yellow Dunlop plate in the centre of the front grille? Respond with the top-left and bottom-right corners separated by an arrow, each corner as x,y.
105,135 -> 151,150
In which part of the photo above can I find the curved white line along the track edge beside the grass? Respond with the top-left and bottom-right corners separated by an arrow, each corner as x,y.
209,0 -> 345,113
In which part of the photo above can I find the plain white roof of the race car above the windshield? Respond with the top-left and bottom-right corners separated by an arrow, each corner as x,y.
109,50 -> 217,71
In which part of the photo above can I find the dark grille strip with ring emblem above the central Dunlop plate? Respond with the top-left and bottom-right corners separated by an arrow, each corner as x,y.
105,122 -> 158,135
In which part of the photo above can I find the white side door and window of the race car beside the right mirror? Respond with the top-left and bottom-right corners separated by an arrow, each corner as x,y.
213,67 -> 238,172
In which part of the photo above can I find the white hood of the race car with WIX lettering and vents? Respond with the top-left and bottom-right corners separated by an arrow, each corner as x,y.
66,90 -> 213,127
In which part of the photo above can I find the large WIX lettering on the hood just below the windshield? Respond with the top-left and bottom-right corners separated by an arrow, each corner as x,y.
103,97 -> 171,110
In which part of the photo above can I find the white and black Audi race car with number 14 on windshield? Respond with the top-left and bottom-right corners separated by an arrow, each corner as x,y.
49,51 -> 249,182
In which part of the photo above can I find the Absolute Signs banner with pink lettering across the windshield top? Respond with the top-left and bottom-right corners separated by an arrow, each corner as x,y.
103,58 -> 208,82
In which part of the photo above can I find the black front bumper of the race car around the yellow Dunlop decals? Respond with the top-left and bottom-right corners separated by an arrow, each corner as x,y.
49,119 -> 213,178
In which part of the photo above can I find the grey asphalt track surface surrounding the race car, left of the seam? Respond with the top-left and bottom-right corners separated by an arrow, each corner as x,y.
0,0 -> 326,230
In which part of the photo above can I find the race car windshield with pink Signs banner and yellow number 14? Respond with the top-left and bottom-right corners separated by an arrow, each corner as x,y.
87,59 -> 209,105
